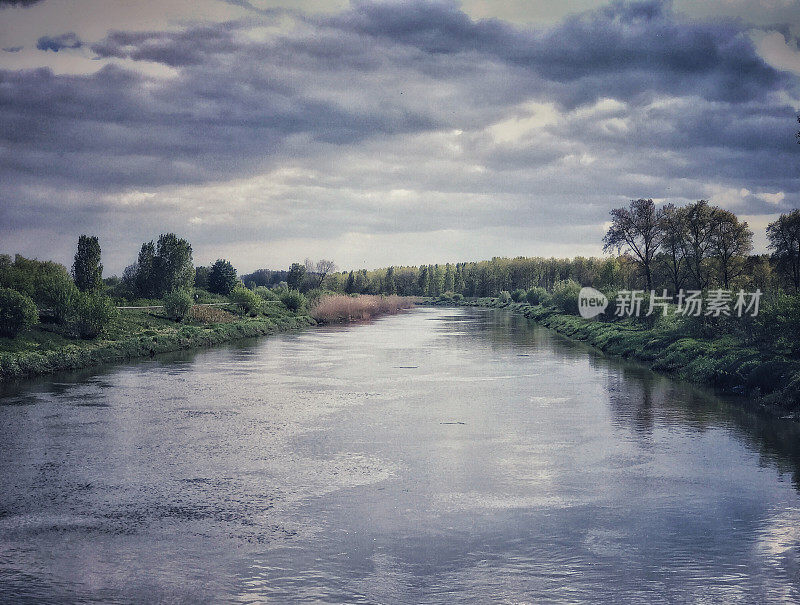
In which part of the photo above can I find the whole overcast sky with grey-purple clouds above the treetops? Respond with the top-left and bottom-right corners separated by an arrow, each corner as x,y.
0,0 -> 800,274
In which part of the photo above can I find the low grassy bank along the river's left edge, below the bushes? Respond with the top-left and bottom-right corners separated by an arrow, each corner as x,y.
0,305 -> 315,382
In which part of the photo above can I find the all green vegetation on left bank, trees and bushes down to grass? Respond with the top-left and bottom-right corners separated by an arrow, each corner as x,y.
0,234 -> 317,381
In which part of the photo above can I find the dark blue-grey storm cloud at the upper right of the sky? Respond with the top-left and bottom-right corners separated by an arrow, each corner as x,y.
321,0 -> 789,107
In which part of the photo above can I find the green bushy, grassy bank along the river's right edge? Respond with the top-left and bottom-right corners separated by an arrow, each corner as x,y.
427,296 -> 800,420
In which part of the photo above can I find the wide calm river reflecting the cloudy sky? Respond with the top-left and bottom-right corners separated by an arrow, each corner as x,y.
0,308 -> 800,603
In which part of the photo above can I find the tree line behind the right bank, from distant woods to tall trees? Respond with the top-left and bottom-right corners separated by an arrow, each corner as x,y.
318,205 -> 800,297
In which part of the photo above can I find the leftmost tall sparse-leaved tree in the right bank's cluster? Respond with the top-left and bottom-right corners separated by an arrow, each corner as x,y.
603,199 -> 662,290
